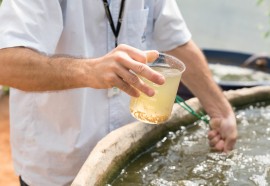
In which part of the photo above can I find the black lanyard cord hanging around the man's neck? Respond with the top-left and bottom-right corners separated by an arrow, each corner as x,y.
103,0 -> 125,47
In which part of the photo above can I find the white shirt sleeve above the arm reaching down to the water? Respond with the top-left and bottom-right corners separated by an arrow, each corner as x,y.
153,0 -> 191,51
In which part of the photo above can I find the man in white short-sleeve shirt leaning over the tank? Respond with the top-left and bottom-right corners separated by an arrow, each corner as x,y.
0,0 -> 237,186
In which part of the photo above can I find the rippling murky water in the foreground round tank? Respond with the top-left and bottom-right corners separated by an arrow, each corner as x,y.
108,103 -> 270,186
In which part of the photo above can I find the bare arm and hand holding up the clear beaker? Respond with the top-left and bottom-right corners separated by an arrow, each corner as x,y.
0,45 -> 165,97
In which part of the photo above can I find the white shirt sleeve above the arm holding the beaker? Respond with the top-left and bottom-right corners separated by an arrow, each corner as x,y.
0,0 -> 63,54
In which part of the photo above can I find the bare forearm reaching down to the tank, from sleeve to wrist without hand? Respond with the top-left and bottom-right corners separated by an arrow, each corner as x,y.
168,41 -> 233,117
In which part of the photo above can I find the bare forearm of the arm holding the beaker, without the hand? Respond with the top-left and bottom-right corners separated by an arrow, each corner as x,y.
0,47 -> 85,91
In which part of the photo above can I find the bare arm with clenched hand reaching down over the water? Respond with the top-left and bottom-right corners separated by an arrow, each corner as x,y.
166,40 -> 237,152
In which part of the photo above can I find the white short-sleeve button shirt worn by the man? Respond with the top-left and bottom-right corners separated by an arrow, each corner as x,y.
0,0 -> 191,186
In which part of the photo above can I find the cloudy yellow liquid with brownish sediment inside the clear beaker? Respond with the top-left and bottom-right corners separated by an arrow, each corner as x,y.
130,66 -> 182,124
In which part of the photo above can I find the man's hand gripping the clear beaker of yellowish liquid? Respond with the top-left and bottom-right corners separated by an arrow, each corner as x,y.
89,44 -> 165,97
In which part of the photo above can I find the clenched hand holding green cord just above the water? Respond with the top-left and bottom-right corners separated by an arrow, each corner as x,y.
208,116 -> 237,153
